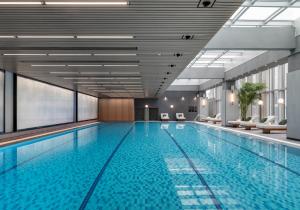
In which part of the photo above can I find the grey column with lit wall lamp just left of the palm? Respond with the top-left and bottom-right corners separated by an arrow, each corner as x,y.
221,81 -> 239,126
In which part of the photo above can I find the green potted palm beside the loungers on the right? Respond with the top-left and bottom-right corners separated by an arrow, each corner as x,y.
237,82 -> 266,120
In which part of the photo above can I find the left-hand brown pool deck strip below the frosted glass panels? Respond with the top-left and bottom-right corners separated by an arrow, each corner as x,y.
0,120 -> 98,147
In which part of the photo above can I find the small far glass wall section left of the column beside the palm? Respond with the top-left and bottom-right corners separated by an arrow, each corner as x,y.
205,86 -> 222,116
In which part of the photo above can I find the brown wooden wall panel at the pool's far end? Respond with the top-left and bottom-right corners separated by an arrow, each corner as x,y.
99,99 -> 134,121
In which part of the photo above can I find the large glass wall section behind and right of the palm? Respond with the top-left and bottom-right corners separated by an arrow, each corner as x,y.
236,63 -> 288,122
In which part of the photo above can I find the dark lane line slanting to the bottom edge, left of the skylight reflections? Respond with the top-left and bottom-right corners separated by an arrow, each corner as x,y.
79,126 -> 133,210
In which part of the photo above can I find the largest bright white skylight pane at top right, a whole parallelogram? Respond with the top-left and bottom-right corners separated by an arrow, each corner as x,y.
240,7 -> 279,20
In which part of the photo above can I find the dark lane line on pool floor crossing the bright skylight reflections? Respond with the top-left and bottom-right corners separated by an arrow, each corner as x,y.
163,129 -> 222,210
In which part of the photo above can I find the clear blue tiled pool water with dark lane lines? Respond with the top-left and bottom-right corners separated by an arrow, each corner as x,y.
0,122 -> 300,210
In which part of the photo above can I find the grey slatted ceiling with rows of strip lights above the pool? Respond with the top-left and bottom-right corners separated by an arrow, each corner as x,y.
0,0 -> 242,97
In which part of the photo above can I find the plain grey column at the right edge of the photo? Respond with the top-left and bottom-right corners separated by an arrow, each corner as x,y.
286,34 -> 300,140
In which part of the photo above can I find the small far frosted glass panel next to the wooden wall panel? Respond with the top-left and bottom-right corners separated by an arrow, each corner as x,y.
78,93 -> 98,121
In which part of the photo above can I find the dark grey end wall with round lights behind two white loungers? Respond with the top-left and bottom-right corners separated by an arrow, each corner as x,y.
135,91 -> 198,120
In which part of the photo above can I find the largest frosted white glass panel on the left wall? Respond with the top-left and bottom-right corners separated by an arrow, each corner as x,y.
17,77 -> 74,130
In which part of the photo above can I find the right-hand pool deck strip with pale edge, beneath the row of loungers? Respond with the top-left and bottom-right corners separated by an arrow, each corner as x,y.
196,122 -> 300,148
